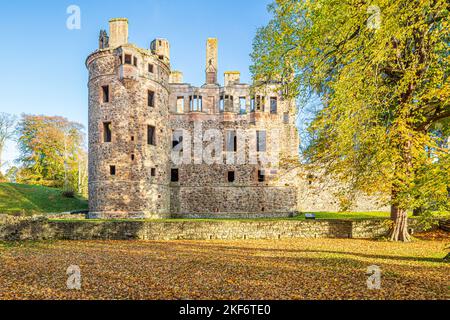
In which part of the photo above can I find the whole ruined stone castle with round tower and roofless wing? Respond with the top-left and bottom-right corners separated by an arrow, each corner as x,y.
86,18 -> 299,218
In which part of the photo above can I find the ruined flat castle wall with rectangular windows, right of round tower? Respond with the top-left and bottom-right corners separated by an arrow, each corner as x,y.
169,84 -> 298,217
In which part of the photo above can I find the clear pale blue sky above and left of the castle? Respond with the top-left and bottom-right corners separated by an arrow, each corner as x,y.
0,0 -> 271,171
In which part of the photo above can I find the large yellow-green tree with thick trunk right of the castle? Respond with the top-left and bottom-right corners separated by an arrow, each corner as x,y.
252,0 -> 450,241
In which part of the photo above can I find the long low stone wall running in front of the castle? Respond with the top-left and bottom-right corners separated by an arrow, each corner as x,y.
0,216 -> 442,241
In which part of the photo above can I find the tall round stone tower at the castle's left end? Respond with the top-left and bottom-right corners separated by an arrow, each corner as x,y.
86,19 -> 171,218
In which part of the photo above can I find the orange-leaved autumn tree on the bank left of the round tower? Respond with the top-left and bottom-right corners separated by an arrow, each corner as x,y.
17,115 -> 86,191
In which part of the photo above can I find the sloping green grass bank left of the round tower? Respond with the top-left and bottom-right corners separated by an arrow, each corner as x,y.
0,183 -> 88,214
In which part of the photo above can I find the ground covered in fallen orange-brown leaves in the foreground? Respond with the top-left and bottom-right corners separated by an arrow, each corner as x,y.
0,237 -> 450,299
